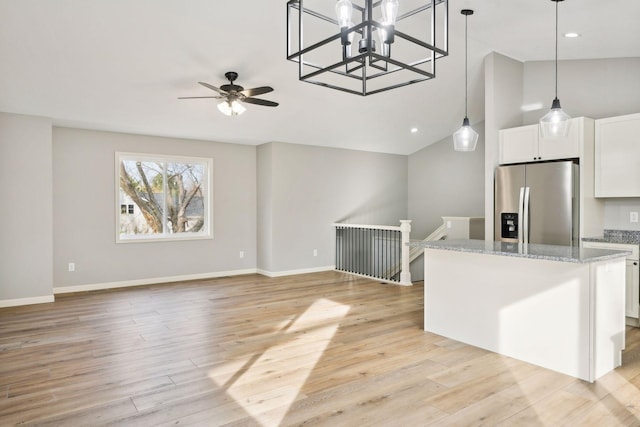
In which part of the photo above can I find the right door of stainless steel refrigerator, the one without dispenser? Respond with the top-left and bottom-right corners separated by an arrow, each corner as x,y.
526,162 -> 579,246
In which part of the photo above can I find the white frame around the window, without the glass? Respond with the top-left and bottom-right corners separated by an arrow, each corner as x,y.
114,151 -> 213,243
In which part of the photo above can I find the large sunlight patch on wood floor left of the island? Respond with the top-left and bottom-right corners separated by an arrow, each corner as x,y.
209,299 -> 350,425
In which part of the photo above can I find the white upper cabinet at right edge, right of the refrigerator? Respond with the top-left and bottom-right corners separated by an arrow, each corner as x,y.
595,114 -> 640,197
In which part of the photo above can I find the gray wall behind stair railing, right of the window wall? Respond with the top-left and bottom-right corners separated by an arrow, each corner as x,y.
258,143 -> 407,273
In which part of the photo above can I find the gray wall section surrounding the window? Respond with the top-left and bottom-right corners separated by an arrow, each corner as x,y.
53,128 -> 257,287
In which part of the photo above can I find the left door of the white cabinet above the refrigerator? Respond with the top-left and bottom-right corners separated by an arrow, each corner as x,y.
498,125 -> 538,165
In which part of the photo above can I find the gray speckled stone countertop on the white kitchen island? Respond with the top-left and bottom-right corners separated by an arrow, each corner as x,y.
411,240 -> 631,264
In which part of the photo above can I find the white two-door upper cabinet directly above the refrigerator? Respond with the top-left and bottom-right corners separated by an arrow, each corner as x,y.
498,117 -> 585,164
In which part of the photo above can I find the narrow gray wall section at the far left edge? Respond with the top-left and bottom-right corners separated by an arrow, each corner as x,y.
0,113 -> 53,301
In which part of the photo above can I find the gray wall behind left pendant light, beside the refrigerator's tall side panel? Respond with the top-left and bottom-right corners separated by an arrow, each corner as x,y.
409,122 -> 485,239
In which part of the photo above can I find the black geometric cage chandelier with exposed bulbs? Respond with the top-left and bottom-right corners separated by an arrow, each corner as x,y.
287,0 -> 449,96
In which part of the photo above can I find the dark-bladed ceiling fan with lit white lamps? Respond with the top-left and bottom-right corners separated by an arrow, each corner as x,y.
178,71 -> 278,116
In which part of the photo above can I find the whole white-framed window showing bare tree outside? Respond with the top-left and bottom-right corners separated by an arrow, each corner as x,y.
116,153 -> 213,242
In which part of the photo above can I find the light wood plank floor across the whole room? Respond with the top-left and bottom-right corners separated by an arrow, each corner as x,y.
0,272 -> 640,426
